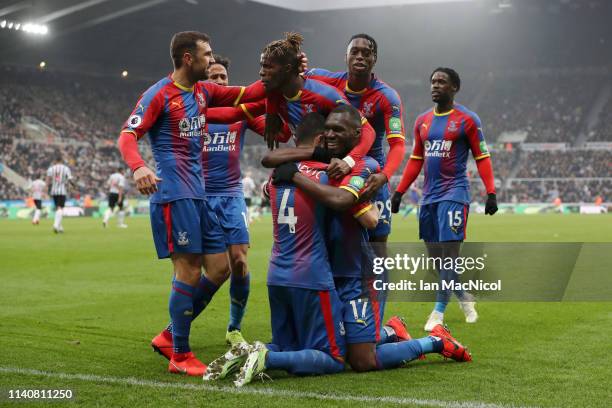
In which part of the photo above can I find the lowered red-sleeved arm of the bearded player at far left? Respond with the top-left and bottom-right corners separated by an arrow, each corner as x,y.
117,87 -> 164,195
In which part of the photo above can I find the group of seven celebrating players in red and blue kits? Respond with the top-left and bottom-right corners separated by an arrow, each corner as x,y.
116,31 -> 497,387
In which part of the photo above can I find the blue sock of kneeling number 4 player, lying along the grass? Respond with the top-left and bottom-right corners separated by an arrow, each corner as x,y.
266,350 -> 344,375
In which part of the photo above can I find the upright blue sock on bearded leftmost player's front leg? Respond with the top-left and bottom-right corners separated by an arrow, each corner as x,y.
168,281 -> 195,353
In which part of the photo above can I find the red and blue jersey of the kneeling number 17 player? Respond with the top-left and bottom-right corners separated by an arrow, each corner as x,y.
327,156 -> 380,278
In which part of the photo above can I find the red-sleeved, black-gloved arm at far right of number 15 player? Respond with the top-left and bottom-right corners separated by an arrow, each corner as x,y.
465,114 -> 497,215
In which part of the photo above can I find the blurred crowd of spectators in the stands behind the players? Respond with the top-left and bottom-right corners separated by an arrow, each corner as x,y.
0,67 -> 612,202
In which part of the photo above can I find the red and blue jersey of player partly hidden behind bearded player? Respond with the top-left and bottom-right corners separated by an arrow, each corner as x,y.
202,115 -> 266,197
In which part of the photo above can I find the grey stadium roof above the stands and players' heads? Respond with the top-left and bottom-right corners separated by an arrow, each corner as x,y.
0,0 -> 612,82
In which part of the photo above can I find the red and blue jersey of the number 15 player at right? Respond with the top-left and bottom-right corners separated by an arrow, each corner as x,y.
410,104 -> 490,204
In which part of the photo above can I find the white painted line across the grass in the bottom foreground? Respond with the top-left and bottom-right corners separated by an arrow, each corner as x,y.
0,367 -> 514,408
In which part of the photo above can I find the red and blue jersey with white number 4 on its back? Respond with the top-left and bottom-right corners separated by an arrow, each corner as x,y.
267,161 -> 334,290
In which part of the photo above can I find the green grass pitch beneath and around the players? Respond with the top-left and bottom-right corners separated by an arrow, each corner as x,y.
0,215 -> 612,407
